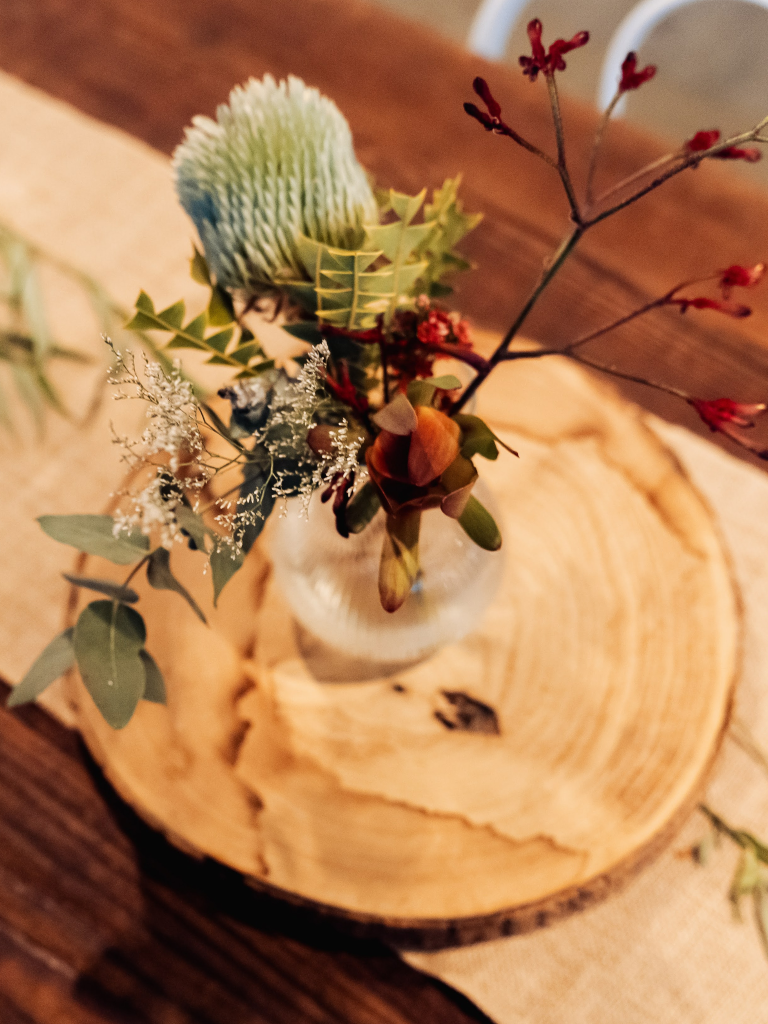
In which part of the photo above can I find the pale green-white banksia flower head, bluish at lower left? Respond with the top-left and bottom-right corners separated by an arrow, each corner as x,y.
173,75 -> 378,294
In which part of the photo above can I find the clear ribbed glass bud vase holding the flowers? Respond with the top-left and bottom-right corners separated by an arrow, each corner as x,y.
270,483 -> 504,666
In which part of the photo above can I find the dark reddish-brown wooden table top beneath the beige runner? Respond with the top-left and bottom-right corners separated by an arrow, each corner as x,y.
0,0 -> 768,1024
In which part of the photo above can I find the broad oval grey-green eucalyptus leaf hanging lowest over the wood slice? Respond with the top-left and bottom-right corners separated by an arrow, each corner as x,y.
73,601 -> 146,729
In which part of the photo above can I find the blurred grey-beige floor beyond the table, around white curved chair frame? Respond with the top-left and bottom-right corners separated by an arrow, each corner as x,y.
364,0 -> 768,187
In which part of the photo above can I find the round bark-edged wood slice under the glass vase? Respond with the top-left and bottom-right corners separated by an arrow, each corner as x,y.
64,348 -> 739,948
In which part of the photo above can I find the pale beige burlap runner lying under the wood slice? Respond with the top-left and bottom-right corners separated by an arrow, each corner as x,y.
0,70 -> 768,1024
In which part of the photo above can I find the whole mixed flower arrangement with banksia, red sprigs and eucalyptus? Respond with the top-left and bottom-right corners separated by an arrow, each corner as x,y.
10,19 -> 768,728
